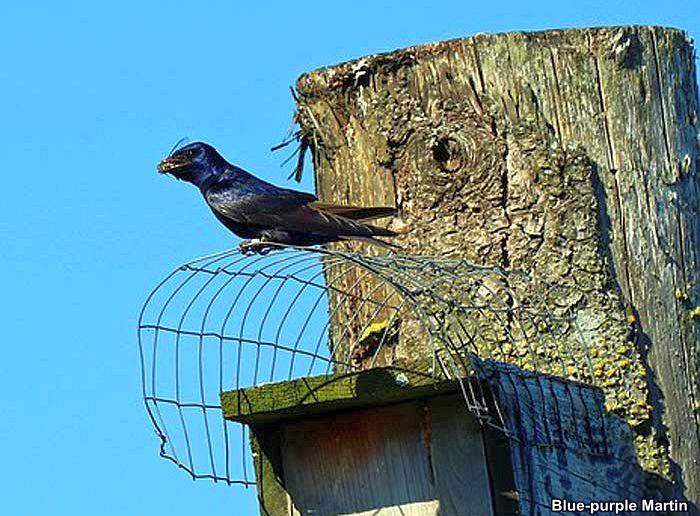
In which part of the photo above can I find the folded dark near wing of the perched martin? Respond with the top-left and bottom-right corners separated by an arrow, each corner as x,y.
205,174 -> 394,237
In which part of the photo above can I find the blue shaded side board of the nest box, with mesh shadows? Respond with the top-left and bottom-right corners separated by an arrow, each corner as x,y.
476,363 -> 645,516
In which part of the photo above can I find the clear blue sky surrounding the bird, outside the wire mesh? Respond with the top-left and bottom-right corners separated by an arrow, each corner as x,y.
0,0 -> 700,516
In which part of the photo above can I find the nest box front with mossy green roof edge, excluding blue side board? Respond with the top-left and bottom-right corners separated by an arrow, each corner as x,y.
222,367 -> 504,515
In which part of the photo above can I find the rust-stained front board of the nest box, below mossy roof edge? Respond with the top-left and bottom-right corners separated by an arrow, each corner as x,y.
282,396 -> 492,516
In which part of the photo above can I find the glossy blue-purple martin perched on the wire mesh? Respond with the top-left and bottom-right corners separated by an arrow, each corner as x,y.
158,142 -> 396,252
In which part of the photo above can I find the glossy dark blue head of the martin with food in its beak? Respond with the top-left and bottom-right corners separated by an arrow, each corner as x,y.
158,142 -> 228,186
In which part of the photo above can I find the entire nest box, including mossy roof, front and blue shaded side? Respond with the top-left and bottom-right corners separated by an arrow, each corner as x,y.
227,361 -> 668,516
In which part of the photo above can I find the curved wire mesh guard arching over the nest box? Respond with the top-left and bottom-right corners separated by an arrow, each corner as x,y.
138,246 -> 608,486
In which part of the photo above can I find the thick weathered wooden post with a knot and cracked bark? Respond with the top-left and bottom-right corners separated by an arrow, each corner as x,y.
297,27 -> 700,504
